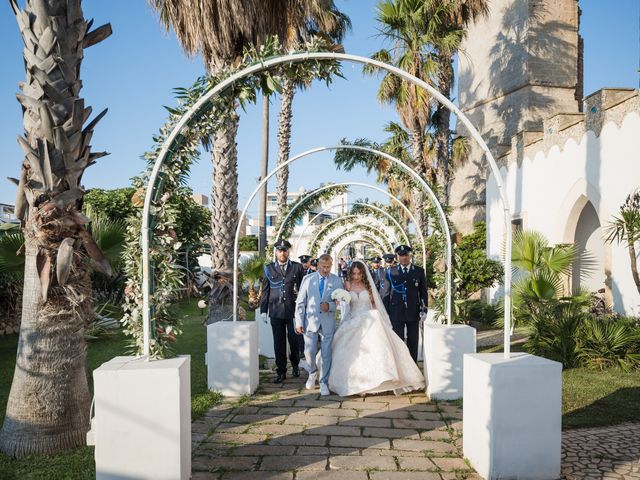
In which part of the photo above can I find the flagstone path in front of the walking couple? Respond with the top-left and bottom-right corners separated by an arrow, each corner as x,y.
192,371 -> 480,480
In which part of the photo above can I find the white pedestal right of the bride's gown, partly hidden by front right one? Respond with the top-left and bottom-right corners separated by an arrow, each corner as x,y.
424,324 -> 476,400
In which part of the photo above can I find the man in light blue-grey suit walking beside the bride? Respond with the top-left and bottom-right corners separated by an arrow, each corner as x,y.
295,254 -> 342,395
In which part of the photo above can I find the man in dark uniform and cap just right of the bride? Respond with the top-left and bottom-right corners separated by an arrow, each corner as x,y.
383,245 -> 427,362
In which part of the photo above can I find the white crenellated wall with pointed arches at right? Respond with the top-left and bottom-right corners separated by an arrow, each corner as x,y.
486,89 -> 640,315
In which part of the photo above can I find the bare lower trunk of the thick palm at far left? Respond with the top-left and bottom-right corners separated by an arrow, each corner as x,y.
0,219 -> 91,457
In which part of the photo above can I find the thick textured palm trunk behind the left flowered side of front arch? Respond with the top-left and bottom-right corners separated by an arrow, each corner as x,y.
211,109 -> 240,271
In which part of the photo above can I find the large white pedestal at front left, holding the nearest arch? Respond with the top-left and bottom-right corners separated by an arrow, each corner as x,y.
93,356 -> 191,480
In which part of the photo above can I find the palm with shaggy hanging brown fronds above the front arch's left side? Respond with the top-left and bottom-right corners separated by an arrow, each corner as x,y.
149,0 -> 290,271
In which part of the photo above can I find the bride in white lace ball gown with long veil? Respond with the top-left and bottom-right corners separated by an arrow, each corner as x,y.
329,260 -> 425,397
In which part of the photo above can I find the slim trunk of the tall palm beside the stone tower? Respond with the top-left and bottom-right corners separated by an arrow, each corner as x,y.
436,53 -> 453,205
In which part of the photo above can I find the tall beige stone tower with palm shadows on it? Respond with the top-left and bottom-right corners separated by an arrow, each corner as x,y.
451,0 -> 583,233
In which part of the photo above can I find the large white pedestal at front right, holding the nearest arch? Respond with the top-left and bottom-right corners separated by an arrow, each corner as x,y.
463,353 -> 562,480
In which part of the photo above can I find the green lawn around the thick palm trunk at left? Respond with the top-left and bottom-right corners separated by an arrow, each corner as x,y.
0,300 -> 222,480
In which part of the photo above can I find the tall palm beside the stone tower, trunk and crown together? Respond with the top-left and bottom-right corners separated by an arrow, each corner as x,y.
425,0 -> 489,205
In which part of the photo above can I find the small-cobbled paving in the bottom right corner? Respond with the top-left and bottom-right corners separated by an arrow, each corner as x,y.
562,423 -> 640,480
